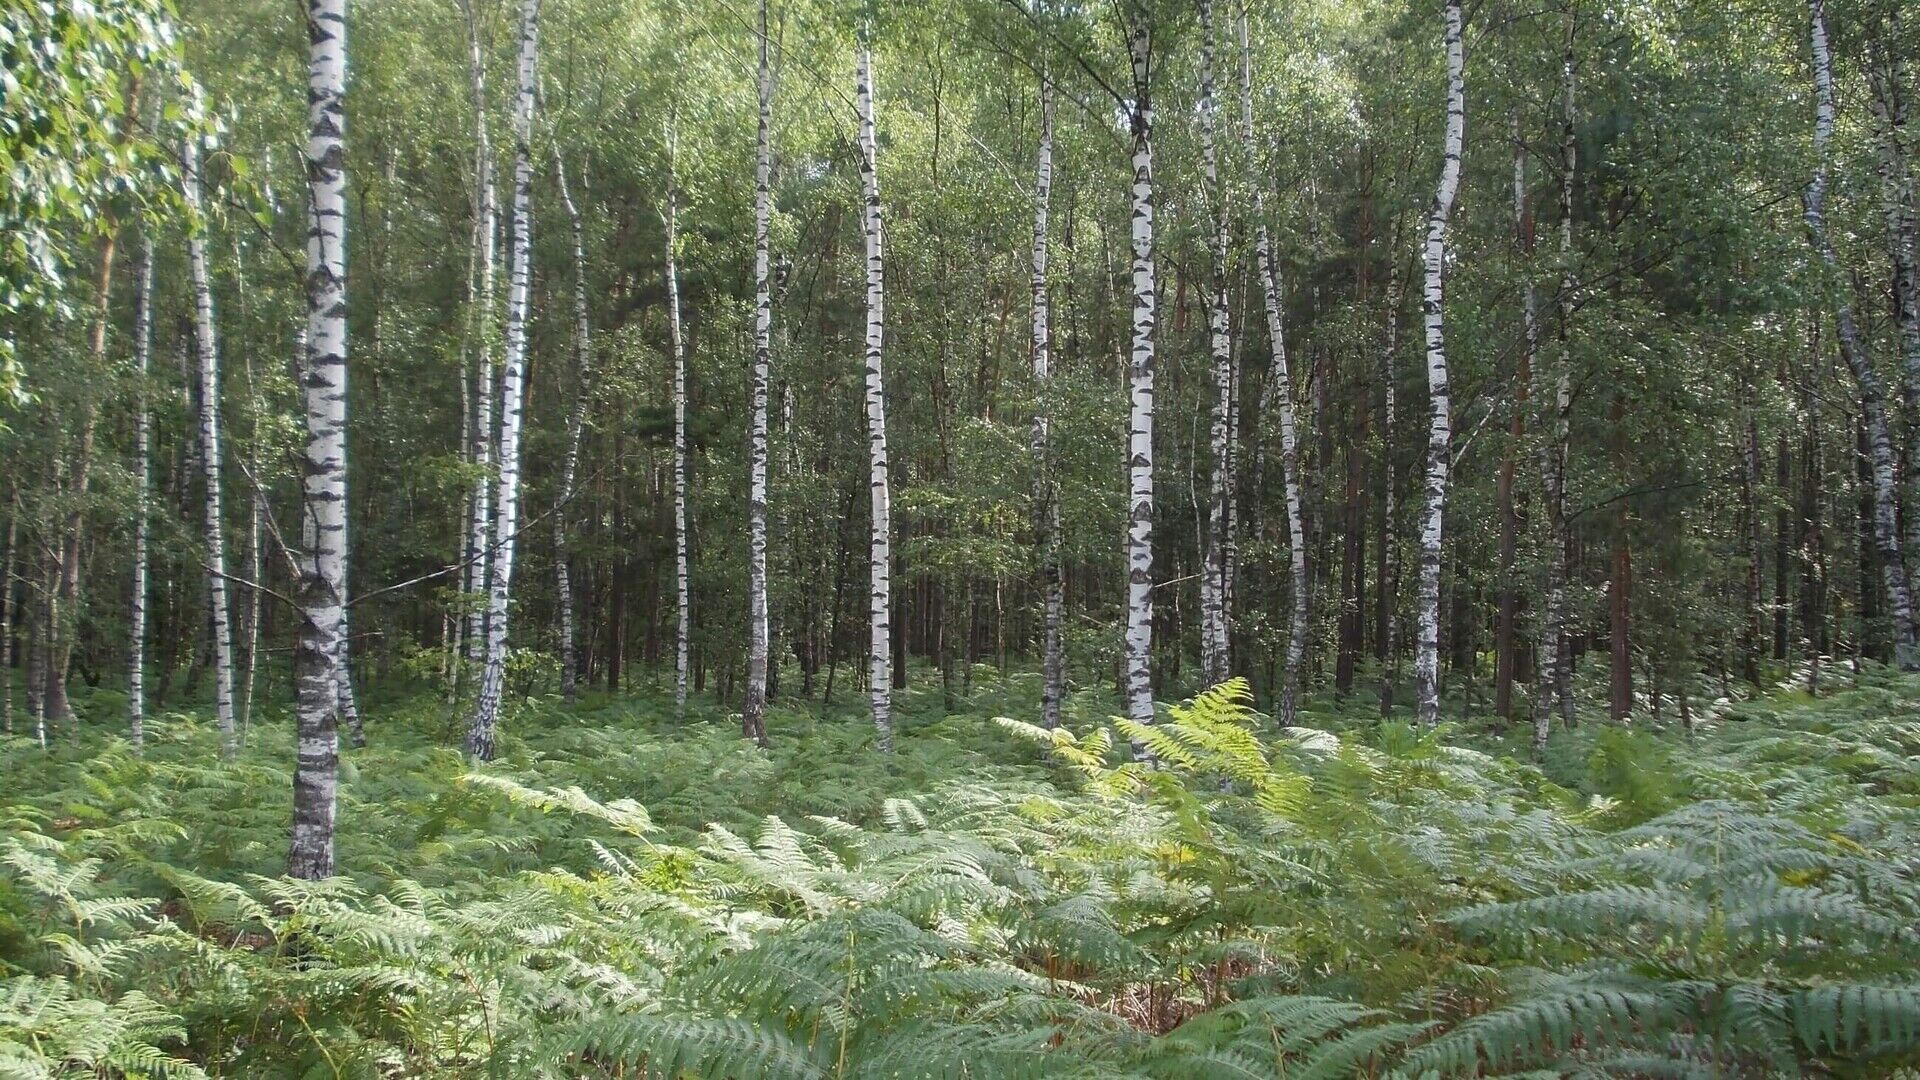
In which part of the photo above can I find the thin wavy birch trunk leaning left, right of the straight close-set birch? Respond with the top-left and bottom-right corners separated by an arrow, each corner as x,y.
1240,4 -> 1311,726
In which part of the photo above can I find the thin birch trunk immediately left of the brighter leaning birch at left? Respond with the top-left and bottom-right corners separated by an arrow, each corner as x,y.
463,0 -> 499,669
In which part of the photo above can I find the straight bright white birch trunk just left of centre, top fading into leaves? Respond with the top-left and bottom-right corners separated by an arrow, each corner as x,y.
854,31 -> 893,753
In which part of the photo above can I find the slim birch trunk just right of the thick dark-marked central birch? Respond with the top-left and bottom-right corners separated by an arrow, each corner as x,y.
1200,0 -> 1233,684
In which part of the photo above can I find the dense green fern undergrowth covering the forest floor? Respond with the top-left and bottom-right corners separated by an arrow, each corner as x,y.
0,671 -> 1920,1078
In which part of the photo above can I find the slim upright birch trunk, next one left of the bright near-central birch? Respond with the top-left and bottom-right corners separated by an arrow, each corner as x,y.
741,0 -> 774,746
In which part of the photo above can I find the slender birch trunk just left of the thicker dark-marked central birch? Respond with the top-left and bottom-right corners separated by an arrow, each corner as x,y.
1029,46 -> 1068,728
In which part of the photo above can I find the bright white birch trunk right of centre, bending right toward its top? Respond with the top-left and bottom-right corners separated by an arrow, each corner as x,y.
1413,0 -> 1467,726
